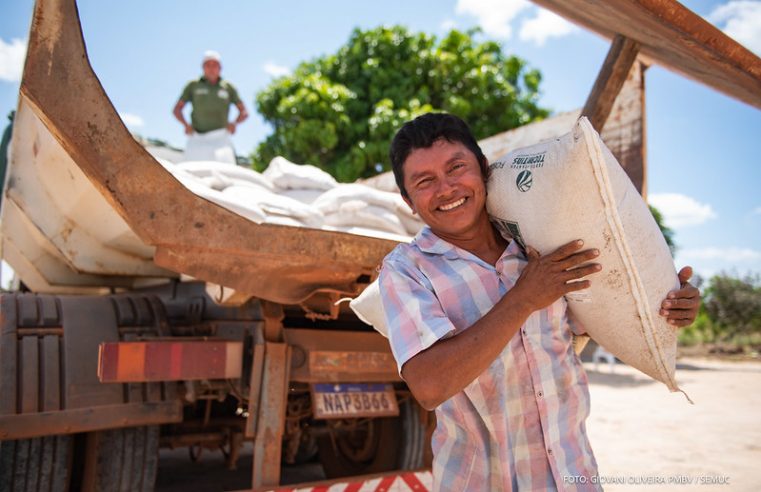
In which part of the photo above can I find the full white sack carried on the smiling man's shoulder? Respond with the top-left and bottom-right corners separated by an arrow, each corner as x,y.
351,118 -> 679,400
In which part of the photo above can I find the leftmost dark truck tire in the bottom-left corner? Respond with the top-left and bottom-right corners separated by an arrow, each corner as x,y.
0,436 -> 73,492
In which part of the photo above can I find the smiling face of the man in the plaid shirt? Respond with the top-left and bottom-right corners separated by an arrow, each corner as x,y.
403,139 -> 488,239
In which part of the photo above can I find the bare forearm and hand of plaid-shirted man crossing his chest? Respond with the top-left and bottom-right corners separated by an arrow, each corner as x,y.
402,241 -> 601,410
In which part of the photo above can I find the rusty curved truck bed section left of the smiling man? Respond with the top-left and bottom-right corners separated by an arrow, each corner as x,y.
0,0 -> 396,304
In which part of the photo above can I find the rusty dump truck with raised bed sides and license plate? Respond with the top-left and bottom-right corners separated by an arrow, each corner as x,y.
5,0 -> 761,490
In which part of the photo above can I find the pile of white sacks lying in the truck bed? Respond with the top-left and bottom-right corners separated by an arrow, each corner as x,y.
159,157 -> 422,241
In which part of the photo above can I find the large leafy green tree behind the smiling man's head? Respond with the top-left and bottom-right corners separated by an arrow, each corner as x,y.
252,26 -> 548,181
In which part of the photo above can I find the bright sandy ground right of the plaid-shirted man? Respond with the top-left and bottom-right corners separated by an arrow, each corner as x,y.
584,358 -> 761,492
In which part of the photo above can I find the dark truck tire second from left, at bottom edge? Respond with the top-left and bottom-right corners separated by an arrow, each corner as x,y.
82,426 -> 159,492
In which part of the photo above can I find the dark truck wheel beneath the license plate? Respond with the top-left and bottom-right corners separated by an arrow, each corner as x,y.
317,400 -> 427,478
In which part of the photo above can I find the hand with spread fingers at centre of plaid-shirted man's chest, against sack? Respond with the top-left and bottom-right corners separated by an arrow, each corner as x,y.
513,240 -> 602,311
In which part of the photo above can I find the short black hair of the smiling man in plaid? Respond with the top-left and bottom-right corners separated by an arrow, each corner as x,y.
389,113 -> 489,198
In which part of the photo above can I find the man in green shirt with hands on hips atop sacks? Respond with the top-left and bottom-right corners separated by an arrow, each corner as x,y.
173,51 -> 248,163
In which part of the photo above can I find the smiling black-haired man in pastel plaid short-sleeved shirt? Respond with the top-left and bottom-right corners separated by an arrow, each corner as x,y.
380,114 -> 700,491
